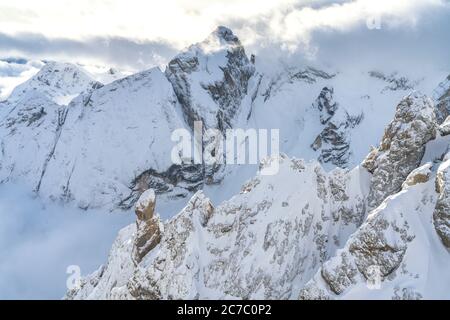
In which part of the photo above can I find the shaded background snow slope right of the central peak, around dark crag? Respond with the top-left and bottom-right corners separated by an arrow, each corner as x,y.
239,67 -> 428,170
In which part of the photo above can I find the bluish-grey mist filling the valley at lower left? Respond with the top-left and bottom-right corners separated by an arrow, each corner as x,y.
0,184 -> 134,299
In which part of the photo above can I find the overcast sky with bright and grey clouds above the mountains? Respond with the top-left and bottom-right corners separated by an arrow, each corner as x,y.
0,0 -> 450,71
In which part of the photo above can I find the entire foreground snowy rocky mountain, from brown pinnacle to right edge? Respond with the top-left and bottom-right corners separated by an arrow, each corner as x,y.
66,92 -> 450,299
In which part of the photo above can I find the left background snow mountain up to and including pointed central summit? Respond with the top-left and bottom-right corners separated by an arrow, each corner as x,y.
0,27 -> 260,209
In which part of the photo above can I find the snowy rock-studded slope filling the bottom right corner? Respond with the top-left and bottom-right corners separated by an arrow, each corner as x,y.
300,156 -> 450,299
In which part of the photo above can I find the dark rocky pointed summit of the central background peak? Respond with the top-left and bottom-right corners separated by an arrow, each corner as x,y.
166,27 -> 255,130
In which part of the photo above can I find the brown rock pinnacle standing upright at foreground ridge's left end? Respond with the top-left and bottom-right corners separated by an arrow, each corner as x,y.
134,189 -> 161,263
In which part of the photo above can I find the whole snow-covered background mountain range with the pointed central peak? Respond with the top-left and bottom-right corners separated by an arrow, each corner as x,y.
0,27 -> 440,214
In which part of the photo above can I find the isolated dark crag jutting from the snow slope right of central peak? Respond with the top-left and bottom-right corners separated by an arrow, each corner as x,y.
311,87 -> 363,167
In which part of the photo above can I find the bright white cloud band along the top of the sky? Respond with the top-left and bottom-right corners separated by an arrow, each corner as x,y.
0,0 -> 444,48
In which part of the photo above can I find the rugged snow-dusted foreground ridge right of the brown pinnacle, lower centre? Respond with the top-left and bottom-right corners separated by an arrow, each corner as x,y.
66,156 -> 368,299
